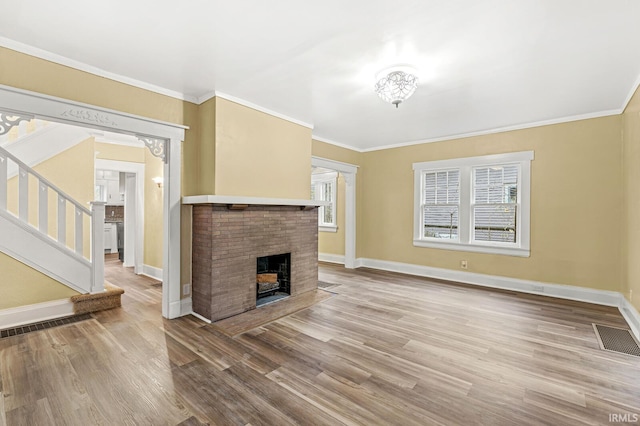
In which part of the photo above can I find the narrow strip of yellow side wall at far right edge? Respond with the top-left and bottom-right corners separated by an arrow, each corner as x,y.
622,85 -> 640,311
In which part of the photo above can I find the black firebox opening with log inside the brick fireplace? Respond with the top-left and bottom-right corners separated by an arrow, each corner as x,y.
256,253 -> 291,306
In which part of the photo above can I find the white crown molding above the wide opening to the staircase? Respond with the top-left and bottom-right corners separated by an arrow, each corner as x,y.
0,37 -> 197,103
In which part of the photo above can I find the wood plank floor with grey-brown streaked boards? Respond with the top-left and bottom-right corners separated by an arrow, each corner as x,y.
0,261 -> 640,426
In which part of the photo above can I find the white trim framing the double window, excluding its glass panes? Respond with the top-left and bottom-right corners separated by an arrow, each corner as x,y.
413,151 -> 534,257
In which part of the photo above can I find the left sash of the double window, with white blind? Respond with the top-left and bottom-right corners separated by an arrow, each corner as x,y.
423,170 -> 460,240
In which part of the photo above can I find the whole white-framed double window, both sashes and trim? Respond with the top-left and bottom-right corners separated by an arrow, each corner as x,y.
413,151 -> 533,257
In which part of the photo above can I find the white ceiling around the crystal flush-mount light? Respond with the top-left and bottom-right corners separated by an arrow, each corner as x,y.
0,0 -> 640,150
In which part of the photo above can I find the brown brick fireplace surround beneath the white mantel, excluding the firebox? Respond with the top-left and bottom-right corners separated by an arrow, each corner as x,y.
192,196 -> 318,321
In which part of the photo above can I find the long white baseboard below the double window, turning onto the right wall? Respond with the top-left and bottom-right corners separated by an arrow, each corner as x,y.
356,258 -> 640,339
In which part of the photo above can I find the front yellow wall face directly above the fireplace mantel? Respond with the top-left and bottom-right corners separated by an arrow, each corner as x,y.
215,97 -> 311,200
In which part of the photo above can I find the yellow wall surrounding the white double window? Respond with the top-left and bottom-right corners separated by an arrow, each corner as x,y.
358,116 -> 623,291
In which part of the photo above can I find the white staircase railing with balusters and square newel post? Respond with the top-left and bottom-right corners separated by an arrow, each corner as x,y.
0,147 -> 105,293
